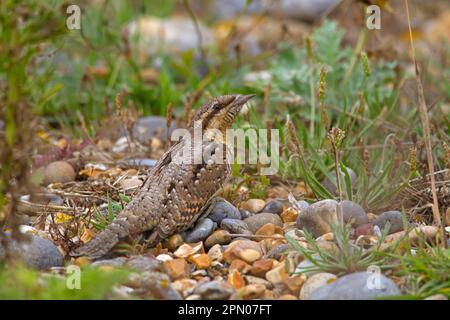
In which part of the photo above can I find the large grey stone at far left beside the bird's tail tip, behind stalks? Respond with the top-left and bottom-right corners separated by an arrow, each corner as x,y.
0,232 -> 64,270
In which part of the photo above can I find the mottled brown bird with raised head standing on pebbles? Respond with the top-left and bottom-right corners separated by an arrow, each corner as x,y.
71,95 -> 254,259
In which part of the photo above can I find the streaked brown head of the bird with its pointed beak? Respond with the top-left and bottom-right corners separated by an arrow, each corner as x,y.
194,94 -> 255,133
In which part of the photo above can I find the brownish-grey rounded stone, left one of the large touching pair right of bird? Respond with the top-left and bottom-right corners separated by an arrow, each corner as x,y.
297,199 -> 338,238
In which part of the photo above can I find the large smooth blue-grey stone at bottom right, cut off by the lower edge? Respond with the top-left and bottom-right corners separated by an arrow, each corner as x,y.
309,272 -> 401,300
